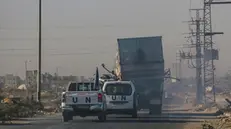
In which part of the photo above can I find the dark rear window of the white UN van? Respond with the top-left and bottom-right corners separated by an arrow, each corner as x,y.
105,83 -> 132,95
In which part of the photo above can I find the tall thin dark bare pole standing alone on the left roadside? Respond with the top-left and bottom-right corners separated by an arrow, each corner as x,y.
37,0 -> 42,102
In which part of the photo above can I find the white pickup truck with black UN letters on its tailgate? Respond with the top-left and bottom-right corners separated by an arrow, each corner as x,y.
61,82 -> 107,122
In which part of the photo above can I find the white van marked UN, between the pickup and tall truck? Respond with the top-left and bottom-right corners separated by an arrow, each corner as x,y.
102,81 -> 138,118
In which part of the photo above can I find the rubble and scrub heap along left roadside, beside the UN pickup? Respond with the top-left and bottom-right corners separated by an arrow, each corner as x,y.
0,88 -> 61,123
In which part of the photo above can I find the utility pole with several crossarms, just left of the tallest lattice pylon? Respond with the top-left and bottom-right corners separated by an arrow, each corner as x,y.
181,9 -> 204,104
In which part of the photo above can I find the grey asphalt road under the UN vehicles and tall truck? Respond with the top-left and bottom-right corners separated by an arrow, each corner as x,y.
0,112 -> 218,129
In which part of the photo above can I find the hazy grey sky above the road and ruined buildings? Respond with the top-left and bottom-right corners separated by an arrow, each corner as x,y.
0,0 -> 231,76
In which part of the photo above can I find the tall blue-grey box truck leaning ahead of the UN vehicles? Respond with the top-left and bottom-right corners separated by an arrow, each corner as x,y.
113,36 -> 165,115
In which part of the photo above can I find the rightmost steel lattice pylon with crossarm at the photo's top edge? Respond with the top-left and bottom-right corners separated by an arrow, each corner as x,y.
203,0 -> 231,103
